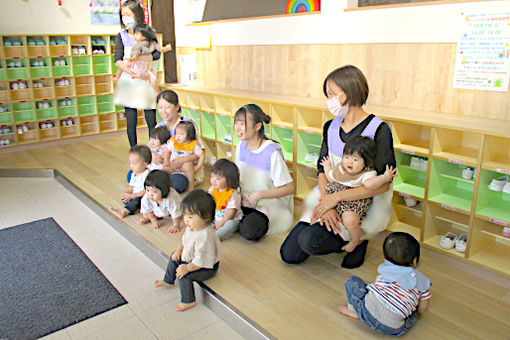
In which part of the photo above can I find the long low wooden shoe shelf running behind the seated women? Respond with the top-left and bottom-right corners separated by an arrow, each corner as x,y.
168,86 -> 510,276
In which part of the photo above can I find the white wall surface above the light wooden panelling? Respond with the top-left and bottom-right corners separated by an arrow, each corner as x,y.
174,0 -> 510,47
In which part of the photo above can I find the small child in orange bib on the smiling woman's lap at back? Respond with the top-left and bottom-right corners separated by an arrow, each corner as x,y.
164,121 -> 205,191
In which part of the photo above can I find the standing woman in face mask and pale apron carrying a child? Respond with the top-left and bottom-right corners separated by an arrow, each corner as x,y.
113,0 -> 161,146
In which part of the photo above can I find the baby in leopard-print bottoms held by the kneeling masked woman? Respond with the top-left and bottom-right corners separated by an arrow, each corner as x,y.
321,137 -> 397,252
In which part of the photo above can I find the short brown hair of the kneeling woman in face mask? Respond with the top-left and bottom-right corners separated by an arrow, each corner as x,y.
322,65 -> 368,106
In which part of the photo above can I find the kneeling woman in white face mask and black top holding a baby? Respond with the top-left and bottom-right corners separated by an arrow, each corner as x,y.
280,65 -> 396,268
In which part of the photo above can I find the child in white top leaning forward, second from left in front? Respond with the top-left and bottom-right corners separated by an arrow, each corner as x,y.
138,170 -> 182,233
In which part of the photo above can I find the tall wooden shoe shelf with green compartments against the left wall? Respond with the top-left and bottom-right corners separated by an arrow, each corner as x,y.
0,33 -> 163,148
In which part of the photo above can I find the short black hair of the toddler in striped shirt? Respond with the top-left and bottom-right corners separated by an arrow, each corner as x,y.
383,232 -> 420,267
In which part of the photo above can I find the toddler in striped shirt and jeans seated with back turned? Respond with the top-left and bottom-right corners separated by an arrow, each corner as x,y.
338,232 -> 431,336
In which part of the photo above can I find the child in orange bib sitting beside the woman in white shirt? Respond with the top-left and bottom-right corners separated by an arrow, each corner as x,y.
209,158 -> 243,240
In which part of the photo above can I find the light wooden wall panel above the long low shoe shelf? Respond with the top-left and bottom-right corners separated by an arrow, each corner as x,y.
178,43 -> 510,120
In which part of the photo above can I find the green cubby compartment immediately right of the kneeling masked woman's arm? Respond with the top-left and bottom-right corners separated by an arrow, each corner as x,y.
393,151 -> 428,199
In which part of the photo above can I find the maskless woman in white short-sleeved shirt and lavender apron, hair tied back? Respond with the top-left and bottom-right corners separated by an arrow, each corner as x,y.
234,104 -> 294,241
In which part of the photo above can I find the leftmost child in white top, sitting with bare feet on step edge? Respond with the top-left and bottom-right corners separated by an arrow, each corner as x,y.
108,145 -> 152,220
